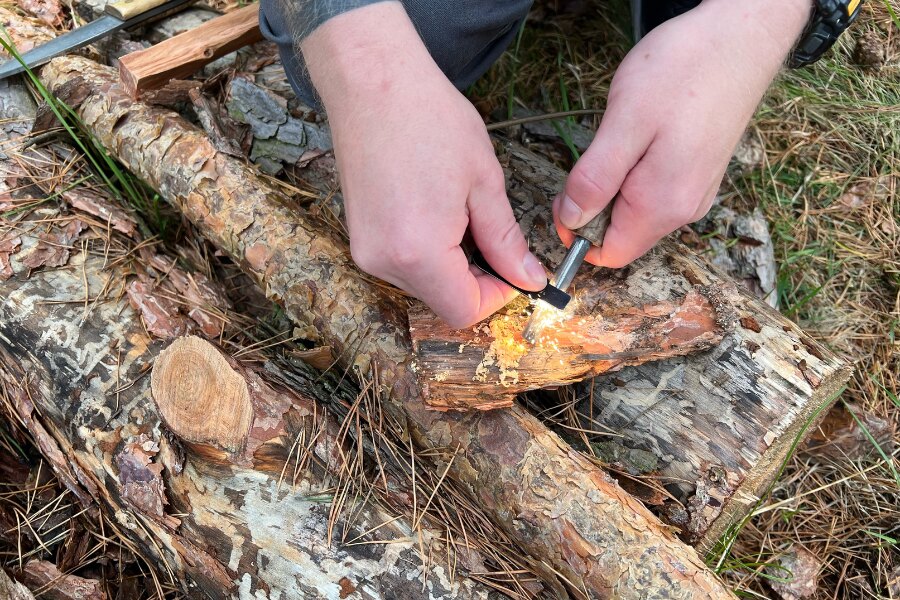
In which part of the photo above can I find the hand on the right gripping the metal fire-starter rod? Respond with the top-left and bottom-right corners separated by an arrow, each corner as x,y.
553,0 -> 811,267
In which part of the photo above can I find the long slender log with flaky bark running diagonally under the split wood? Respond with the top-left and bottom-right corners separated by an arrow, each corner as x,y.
41,57 -> 732,598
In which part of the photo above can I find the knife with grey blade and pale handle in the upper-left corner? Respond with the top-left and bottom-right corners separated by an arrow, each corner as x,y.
0,0 -> 193,79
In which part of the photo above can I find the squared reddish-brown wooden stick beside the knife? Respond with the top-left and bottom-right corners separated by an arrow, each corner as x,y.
119,4 -> 262,98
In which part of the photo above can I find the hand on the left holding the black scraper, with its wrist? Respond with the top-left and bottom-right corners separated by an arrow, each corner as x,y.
302,2 -> 547,327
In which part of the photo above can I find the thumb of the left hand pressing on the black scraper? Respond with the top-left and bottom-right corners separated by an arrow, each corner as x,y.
468,170 -> 547,290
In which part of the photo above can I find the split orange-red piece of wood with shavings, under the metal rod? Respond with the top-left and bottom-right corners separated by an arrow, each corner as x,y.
409,255 -> 735,409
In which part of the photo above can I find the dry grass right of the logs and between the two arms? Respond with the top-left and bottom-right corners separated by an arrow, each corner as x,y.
472,0 -> 900,599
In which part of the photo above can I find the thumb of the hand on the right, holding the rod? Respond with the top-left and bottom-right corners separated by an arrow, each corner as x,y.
557,106 -> 653,230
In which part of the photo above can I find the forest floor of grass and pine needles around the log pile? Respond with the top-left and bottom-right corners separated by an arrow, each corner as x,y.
0,0 -> 900,599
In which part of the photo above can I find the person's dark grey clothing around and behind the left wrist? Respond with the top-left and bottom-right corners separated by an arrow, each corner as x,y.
259,0 -> 532,108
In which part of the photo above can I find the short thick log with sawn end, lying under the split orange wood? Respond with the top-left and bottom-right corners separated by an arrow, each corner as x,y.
501,144 -> 852,554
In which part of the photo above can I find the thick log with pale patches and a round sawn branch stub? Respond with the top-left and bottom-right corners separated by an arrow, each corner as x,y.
0,218 -> 489,600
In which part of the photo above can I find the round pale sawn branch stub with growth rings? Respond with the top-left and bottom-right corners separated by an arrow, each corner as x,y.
150,337 -> 253,458
